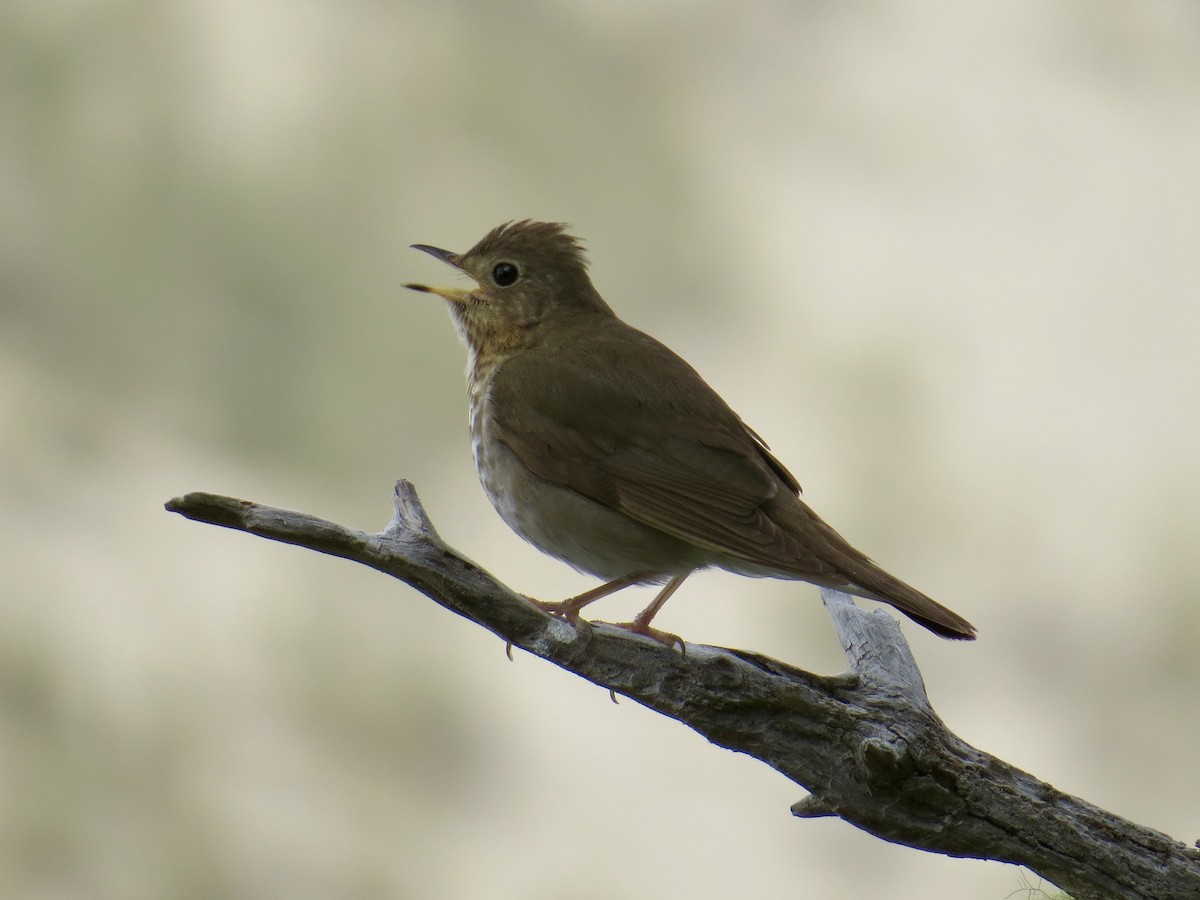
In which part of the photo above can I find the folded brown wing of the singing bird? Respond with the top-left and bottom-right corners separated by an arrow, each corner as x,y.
492,322 -> 846,584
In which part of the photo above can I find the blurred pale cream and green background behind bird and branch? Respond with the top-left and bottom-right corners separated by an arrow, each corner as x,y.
0,0 -> 1200,900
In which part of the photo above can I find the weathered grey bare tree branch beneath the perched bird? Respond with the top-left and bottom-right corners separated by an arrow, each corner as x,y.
167,481 -> 1200,900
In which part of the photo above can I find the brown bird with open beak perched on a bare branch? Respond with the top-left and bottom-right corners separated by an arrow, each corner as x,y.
406,221 -> 976,644
